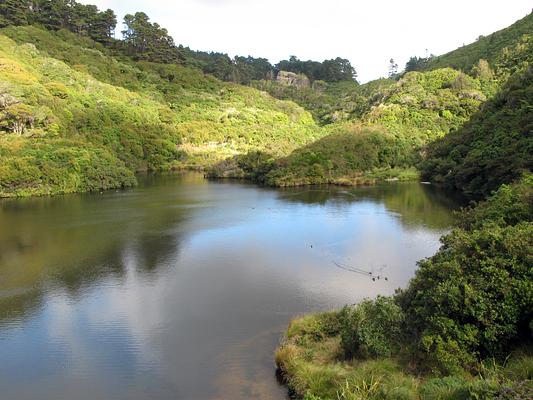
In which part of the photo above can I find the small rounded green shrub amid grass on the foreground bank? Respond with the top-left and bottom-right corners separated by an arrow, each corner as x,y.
339,296 -> 404,358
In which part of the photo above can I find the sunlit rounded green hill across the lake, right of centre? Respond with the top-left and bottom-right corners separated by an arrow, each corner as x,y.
251,68 -> 492,186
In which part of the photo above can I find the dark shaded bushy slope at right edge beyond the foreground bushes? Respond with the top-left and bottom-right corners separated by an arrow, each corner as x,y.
421,67 -> 533,198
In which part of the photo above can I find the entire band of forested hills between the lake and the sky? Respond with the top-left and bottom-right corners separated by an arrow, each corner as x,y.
0,0 -> 533,196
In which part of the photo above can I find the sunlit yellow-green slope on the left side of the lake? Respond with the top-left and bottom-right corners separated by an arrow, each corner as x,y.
0,27 -> 320,196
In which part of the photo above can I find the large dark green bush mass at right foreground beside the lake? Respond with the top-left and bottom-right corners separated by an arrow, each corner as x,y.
397,176 -> 533,373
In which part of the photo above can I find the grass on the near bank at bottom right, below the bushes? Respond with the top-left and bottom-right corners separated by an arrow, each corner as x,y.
275,312 -> 533,400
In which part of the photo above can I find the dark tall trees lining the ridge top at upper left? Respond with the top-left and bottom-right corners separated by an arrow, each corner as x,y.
0,0 -> 362,84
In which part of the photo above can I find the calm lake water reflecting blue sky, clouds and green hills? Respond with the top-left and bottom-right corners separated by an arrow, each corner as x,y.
0,174 -> 457,400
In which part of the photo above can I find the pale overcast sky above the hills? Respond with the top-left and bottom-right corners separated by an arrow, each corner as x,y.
81,0 -> 532,82
